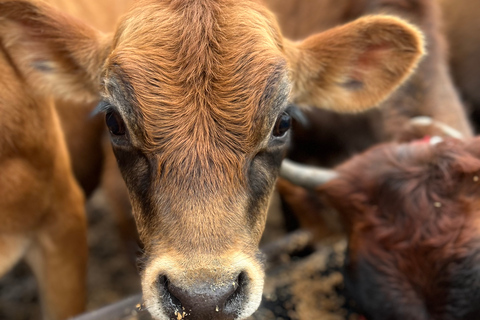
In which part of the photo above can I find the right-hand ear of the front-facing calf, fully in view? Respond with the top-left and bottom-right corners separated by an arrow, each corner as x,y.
285,16 -> 424,112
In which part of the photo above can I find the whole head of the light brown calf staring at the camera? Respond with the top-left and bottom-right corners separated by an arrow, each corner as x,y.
0,0 -> 423,319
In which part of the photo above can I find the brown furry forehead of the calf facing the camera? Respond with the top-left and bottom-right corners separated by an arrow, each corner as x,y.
105,0 -> 289,153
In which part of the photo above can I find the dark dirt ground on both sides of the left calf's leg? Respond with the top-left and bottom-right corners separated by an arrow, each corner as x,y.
0,192 -> 140,320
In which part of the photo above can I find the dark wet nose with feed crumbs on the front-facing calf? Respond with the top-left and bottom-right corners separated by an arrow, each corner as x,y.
159,272 -> 245,320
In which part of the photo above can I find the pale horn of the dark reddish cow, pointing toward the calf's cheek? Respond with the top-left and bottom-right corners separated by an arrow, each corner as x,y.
280,159 -> 338,189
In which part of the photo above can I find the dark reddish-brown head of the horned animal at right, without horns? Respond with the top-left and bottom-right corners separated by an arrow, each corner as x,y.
321,138 -> 480,320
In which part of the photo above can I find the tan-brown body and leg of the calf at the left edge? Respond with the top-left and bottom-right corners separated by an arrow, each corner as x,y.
0,21 -> 87,319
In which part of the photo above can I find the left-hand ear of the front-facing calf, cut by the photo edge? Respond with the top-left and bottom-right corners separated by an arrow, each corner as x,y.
0,0 -> 111,101
